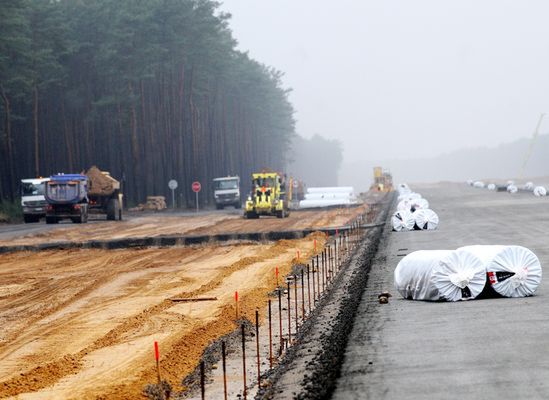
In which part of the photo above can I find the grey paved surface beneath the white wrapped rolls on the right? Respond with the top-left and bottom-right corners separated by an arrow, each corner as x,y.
333,184 -> 549,400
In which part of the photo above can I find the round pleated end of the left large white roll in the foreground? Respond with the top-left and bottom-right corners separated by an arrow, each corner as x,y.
432,249 -> 486,301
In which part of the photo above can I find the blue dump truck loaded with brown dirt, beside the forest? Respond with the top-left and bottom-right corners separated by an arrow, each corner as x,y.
46,166 -> 123,224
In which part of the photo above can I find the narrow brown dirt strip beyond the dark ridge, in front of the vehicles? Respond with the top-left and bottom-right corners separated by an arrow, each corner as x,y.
0,205 -> 367,246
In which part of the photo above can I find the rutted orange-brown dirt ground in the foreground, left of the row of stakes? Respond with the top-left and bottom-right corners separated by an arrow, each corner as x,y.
0,233 -> 326,399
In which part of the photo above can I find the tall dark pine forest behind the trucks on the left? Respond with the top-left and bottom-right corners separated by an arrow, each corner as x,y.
0,0 -> 294,204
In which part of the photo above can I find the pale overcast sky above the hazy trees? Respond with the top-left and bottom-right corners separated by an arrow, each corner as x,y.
221,0 -> 549,162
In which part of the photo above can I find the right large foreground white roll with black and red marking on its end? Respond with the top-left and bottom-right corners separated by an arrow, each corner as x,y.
460,246 -> 542,297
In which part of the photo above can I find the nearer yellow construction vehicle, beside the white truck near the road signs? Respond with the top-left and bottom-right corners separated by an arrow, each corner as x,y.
244,172 -> 290,219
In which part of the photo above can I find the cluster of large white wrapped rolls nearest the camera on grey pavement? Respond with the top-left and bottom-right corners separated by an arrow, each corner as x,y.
395,246 -> 542,301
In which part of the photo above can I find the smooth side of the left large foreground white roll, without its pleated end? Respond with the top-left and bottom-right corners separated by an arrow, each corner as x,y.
395,250 -> 453,301
